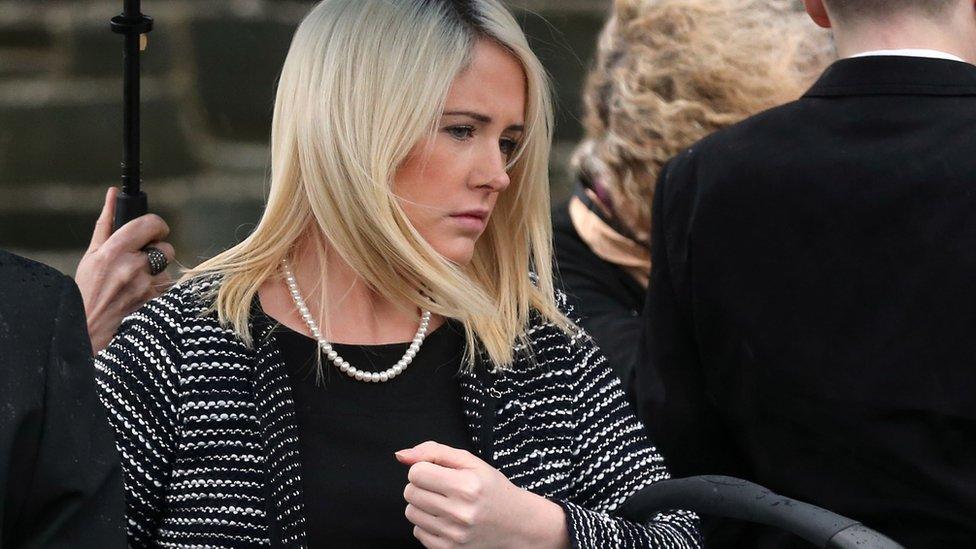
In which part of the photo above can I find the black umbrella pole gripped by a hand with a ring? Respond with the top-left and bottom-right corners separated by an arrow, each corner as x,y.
112,0 -> 152,229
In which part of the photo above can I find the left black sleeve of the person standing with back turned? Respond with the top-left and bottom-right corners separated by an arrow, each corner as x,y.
635,153 -> 742,477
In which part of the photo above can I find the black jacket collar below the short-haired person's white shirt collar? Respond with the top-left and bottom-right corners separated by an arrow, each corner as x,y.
804,56 -> 976,97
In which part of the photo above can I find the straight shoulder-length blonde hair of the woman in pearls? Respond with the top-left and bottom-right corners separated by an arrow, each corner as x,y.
184,0 -> 571,367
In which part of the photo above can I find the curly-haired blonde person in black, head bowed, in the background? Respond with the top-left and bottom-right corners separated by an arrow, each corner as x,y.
553,0 -> 834,390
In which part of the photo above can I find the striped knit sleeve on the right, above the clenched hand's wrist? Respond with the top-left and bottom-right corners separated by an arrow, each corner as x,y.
556,300 -> 701,548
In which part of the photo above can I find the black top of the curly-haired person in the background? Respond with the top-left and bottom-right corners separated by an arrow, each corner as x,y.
552,186 -> 646,396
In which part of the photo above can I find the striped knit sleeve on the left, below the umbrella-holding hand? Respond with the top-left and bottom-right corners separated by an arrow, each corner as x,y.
95,290 -> 182,547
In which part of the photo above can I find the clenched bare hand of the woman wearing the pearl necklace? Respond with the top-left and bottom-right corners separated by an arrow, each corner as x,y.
396,442 -> 569,549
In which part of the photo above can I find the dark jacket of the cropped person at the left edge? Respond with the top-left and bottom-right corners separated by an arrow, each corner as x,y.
0,251 -> 126,549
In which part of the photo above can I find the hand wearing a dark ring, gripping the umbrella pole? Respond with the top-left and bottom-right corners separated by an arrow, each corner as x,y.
75,187 -> 175,354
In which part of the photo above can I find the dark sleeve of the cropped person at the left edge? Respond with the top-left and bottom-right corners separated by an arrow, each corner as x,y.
8,277 -> 126,548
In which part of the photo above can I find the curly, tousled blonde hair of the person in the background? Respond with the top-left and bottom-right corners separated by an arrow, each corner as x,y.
572,0 -> 834,230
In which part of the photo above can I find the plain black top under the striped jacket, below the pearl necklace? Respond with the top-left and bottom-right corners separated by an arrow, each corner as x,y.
274,314 -> 473,547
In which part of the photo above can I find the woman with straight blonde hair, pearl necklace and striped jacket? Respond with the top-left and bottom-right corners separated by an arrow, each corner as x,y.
98,0 -> 698,547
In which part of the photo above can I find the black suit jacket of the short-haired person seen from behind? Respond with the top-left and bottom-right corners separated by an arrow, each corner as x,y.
636,57 -> 976,547
